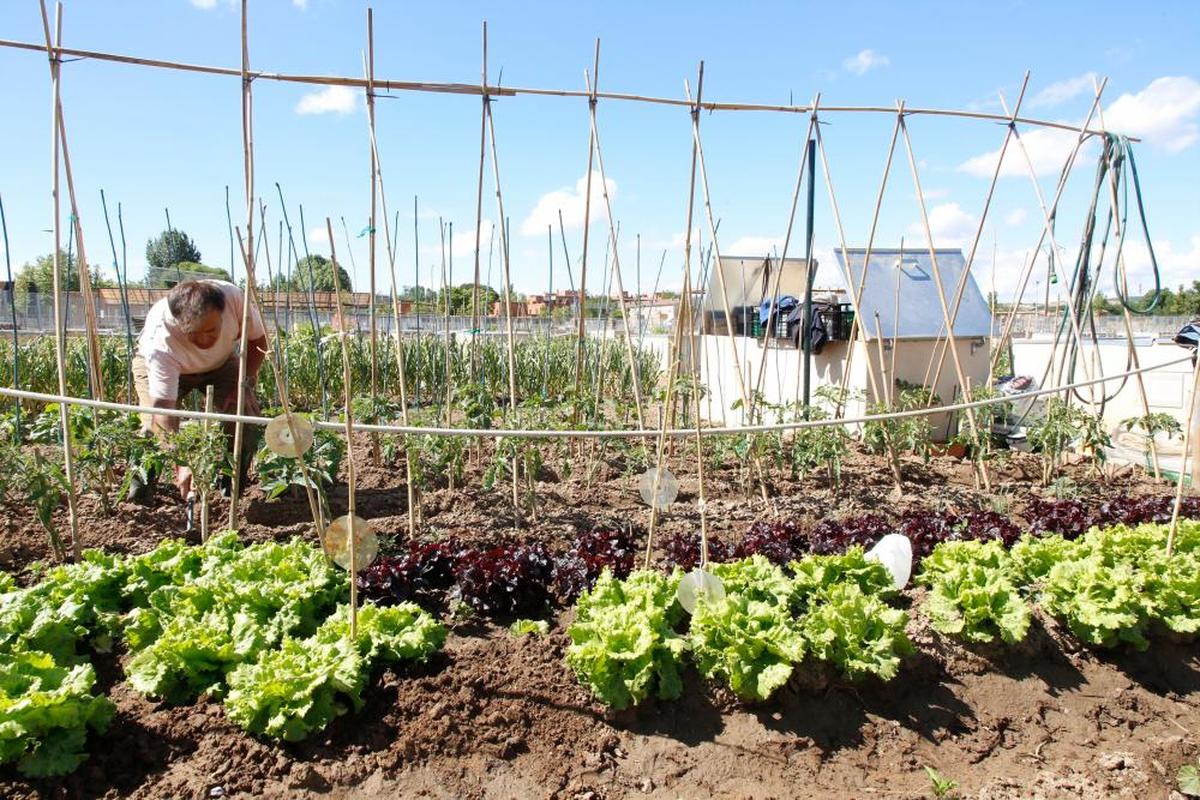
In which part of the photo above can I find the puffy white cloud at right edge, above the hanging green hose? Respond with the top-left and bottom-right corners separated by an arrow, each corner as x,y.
1104,78 -> 1200,152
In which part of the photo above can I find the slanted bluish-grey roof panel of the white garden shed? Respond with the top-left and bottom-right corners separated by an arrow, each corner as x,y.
835,247 -> 991,339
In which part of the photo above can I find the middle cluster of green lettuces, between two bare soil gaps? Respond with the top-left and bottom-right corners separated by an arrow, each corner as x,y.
566,548 -> 912,709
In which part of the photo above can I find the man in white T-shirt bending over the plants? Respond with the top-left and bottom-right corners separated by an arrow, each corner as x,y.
133,281 -> 266,497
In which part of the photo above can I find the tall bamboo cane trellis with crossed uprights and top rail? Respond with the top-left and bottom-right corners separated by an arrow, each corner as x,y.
0,0 -> 1185,556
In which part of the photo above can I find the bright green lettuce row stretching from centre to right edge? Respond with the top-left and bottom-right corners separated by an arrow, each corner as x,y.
566,521 -> 1200,709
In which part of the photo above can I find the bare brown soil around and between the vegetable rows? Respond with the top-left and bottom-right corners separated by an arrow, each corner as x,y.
0,453 -> 1200,800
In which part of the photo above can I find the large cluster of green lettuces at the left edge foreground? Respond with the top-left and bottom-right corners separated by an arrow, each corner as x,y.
0,533 -> 445,775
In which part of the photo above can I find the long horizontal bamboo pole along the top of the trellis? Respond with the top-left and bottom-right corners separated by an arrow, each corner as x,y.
0,38 -> 1141,142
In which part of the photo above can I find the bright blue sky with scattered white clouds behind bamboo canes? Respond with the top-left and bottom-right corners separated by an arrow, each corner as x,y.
0,0 -> 1200,303
